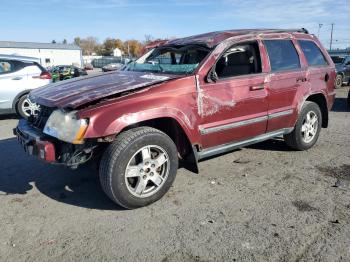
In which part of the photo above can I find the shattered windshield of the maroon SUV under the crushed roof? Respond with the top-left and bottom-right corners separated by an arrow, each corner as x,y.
124,45 -> 210,75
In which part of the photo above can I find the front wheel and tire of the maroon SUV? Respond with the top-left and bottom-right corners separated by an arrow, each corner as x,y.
99,127 -> 178,209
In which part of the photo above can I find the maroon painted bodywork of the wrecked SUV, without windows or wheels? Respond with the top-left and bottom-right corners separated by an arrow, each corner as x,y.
33,30 -> 335,148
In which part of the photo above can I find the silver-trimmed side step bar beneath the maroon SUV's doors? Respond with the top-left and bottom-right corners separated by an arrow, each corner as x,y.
197,128 -> 294,160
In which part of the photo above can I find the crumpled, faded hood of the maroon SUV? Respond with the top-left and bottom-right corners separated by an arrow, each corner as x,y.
30,71 -> 181,109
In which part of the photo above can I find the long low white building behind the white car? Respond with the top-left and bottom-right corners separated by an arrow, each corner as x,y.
0,41 -> 83,67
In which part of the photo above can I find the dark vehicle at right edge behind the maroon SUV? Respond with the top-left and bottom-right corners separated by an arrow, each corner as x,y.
332,55 -> 350,88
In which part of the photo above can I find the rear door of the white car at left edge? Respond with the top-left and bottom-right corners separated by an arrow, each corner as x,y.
0,59 -> 27,109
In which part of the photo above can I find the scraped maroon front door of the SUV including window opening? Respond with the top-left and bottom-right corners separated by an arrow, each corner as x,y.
198,41 -> 268,148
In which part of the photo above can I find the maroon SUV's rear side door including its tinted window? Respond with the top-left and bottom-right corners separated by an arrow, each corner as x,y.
264,39 -> 307,132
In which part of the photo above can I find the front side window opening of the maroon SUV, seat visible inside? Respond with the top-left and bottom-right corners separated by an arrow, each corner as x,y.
215,42 -> 262,79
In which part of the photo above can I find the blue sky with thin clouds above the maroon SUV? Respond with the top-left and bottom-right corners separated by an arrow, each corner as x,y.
0,0 -> 350,48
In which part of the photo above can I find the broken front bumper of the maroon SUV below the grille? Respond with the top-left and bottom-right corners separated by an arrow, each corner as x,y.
13,119 -> 56,163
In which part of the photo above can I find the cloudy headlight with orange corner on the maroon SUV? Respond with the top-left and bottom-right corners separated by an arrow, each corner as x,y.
44,110 -> 88,144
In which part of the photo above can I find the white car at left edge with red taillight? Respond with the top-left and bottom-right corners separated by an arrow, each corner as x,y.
0,55 -> 51,118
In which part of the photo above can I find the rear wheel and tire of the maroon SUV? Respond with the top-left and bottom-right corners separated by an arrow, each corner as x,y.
284,101 -> 322,150
